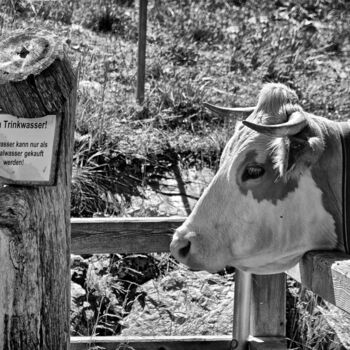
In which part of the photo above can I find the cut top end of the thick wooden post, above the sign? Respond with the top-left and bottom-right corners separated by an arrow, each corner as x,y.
0,30 -> 76,118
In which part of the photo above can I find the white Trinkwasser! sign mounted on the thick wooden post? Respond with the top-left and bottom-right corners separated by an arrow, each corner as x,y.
0,114 -> 59,184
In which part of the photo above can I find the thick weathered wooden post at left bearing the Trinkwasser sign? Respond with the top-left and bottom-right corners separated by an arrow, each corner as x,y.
0,31 -> 76,350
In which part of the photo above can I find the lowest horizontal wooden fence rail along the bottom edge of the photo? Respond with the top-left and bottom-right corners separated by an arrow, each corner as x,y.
71,336 -> 231,350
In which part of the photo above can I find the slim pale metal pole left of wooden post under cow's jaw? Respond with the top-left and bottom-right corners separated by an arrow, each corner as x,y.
233,269 -> 252,350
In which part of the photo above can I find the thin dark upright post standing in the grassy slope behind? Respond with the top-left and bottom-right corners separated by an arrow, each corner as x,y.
136,0 -> 148,104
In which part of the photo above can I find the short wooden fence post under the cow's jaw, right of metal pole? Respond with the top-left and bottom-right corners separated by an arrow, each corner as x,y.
250,273 -> 287,350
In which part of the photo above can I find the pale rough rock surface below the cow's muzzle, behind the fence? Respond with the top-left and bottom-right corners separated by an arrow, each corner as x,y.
121,270 -> 234,336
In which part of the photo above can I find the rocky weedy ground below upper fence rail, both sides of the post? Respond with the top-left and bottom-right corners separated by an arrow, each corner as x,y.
71,254 -> 350,350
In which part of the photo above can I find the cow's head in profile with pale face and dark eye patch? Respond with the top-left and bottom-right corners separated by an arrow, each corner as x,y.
170,84 -> 336,274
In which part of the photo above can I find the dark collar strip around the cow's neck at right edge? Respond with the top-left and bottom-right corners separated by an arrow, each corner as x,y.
339,121 -> 350,254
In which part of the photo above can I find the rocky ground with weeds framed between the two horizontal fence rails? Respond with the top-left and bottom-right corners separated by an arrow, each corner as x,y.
71,255 -> 234,335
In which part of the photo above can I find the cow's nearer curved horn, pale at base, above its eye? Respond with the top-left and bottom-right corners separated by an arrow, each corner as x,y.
242,112 -> 307,137
